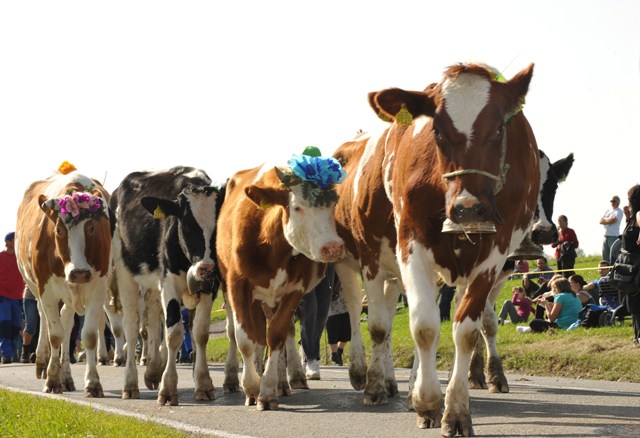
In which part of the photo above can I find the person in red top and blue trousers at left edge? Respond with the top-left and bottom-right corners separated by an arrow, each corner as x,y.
0,232 -> 24,364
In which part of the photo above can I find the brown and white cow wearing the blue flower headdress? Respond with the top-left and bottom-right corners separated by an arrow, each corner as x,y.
217,157 -> 344,410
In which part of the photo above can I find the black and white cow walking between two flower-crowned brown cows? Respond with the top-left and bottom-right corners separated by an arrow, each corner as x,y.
111,167 -> 224,405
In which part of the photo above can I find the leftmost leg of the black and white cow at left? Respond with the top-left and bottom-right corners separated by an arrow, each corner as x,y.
116,268 -> 140,399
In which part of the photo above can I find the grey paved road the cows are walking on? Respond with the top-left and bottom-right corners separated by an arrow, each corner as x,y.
0,364 -> 640,438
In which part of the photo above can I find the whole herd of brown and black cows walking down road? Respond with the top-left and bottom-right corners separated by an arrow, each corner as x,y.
16,64 -> 573,436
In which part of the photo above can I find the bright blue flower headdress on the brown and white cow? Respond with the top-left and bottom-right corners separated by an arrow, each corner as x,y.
279,147 -> 347,207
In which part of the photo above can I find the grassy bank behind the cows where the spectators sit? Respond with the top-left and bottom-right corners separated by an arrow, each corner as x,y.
207,257 -> 640,382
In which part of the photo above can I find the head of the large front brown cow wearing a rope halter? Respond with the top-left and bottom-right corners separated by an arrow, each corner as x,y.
369,65 -> 533,231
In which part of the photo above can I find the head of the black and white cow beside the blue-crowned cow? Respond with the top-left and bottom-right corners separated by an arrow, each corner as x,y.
140,186 -> 223,281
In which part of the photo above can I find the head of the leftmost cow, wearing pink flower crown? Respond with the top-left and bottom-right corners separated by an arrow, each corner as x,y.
38,188 -> 112,288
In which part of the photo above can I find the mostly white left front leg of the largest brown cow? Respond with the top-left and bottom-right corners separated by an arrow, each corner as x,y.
401,258 -> 442,429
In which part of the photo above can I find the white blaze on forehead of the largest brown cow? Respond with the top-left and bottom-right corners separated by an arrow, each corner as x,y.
442,74 -> 491,147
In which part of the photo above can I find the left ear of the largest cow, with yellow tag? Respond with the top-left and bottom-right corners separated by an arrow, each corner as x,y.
369,88 -> 436,125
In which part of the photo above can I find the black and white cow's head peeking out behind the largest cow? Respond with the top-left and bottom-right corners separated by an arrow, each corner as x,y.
531,151 -> 574,245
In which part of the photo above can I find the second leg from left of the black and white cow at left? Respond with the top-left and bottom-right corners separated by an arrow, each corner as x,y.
144,287 -> 162,389
